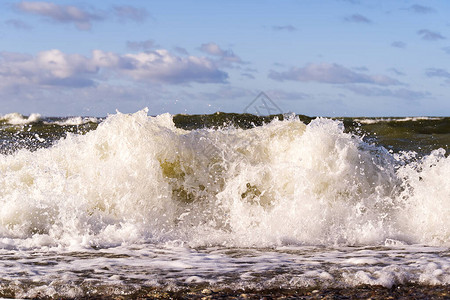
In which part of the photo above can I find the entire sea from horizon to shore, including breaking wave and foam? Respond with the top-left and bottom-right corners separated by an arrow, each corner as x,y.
0,109 -> 450,298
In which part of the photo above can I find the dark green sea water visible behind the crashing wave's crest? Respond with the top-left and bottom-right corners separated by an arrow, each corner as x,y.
0,113 -> 450,155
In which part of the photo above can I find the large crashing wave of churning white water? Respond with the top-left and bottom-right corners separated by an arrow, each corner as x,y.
0,110 -> 450,250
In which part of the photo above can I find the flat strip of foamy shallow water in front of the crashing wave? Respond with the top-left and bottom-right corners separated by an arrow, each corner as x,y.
0,244 -> 450,298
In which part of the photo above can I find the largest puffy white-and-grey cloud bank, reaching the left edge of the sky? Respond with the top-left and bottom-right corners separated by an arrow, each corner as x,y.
0,49 -> 228,90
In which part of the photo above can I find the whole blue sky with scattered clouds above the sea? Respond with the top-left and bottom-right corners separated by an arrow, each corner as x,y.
0,0 -> 450,117
